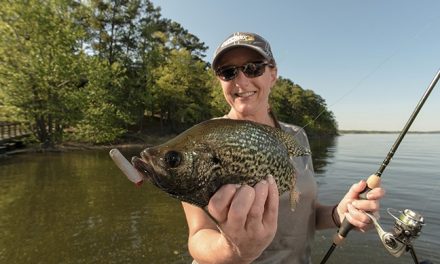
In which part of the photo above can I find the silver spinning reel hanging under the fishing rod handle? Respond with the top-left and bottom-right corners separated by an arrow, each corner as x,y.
367,208 -> 425,264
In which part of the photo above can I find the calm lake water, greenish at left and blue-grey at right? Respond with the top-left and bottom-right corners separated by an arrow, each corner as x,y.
0,134 -> 440,263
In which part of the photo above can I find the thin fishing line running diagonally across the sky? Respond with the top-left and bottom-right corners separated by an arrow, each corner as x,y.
297,16 -> 440,133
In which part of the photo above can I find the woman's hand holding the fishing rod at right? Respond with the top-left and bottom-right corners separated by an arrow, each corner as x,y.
336,180 -> 385,232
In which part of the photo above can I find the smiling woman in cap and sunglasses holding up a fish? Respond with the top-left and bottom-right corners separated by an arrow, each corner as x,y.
183,32 -> 384,264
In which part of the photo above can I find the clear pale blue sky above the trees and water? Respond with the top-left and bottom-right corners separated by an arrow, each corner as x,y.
152,0 -> 440,131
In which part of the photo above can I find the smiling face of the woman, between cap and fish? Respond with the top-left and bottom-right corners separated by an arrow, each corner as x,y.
218,48 -> 277,117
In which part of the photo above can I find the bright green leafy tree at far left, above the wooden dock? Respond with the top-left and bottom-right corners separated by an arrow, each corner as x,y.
0,0 -> 89,146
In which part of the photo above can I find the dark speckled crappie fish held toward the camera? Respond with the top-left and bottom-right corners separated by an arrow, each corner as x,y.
132,119 -> 310,208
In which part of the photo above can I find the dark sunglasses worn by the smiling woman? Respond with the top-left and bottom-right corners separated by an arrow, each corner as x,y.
215,61 -> 273,81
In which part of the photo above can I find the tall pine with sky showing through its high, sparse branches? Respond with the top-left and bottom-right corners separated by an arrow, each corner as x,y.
88,0 -> 207,130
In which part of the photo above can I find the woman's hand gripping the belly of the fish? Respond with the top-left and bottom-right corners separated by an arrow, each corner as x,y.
207,176 -> 279,263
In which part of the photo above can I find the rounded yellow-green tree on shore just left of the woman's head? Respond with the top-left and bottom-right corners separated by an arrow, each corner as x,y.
152,49 -> 211,131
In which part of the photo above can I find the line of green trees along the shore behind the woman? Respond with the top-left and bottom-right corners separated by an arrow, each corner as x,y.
0,0 -> 337,146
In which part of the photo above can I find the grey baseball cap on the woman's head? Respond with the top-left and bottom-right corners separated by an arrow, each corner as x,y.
212,32 -> 275,70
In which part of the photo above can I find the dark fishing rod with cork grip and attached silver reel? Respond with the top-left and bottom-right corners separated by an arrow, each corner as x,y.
321,70 -> 440,264
